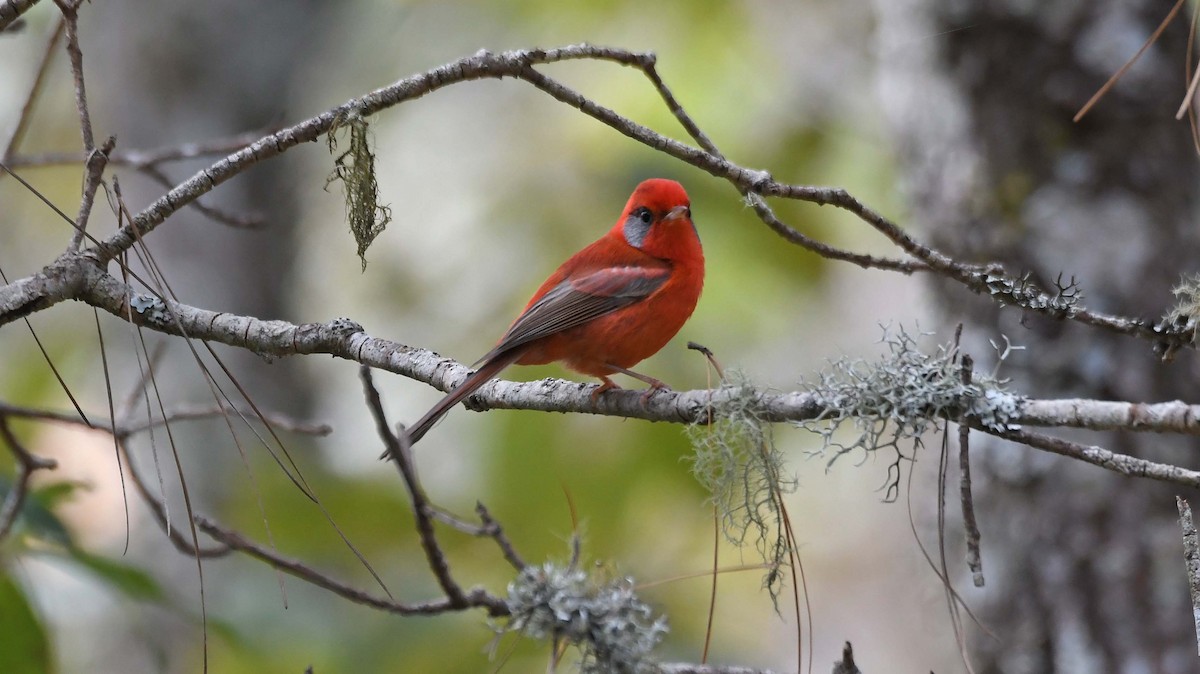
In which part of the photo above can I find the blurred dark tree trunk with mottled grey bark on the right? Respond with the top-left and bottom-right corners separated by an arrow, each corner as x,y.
877,0 -> 1200,673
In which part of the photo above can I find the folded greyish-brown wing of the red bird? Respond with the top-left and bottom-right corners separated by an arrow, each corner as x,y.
479,266 -> 671,362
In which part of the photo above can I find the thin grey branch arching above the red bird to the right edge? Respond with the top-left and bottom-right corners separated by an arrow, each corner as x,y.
0,44 -> 1193,347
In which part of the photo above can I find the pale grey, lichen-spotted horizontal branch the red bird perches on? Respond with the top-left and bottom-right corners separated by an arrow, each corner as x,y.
65,267 -> 1200,435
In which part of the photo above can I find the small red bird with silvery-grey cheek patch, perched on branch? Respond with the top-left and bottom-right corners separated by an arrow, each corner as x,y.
407,179 -> 704,443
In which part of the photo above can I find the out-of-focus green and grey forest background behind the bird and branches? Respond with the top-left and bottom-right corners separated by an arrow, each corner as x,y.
0,0 -> 1196,673
